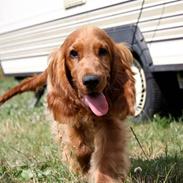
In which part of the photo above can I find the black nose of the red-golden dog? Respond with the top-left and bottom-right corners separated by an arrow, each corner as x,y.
83,75 -> 100,89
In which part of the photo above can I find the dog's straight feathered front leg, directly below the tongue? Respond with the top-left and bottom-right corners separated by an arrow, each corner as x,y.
90,119 -> 129,183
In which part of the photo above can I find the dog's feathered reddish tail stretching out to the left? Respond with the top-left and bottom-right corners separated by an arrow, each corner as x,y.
0,69 -> 47,105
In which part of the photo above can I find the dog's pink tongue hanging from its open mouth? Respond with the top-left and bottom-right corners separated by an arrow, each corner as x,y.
84,93 -> 109,116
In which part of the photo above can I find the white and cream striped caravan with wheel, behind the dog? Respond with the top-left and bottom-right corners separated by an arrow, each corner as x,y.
0,0 -> 183,121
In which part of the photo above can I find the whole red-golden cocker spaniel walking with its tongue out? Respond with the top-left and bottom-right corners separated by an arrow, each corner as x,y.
0,26 -> 135,183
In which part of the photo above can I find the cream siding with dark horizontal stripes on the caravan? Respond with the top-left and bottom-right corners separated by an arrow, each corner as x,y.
0,0 -> 183,74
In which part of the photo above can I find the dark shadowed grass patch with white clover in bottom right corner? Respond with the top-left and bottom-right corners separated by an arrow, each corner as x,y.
130,156 -> 183,183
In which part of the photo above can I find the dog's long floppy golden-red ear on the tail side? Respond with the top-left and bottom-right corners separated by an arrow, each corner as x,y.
47,48 -> 77,121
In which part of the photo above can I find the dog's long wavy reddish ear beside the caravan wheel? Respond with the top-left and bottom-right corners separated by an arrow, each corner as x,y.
108,44 -> 135,116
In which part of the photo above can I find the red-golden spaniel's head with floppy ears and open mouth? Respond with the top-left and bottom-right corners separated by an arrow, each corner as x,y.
49,27 -> 134,116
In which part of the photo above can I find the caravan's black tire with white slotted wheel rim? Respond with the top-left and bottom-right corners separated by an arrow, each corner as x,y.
132,59 -> 162,122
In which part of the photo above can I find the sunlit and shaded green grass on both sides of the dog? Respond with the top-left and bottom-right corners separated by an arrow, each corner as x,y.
0,78 -> 183,183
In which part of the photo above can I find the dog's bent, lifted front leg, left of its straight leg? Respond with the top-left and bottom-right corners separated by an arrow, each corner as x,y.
52,122 -> 93,174
